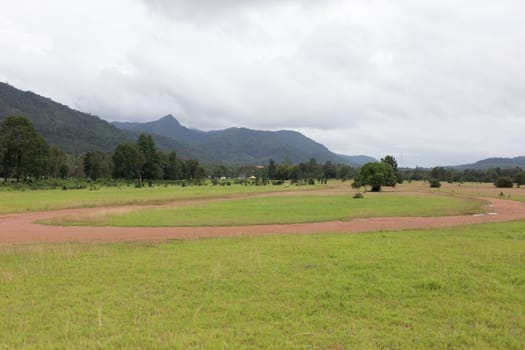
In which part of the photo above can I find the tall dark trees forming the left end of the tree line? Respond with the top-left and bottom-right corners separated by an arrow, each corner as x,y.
0,116 -> 206,183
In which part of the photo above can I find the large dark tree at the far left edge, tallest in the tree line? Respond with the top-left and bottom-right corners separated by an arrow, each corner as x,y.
0,116 -> 49,182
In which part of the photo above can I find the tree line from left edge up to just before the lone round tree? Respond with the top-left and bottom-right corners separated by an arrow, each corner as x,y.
0,116 -> 356,184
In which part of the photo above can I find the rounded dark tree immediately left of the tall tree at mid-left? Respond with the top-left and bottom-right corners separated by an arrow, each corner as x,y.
112,143 -> 144,180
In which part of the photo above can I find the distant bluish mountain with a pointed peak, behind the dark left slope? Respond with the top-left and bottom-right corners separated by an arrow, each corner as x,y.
113,115 -> 375,166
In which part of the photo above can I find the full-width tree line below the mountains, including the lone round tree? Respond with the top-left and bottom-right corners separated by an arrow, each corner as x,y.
0,116 -> 525,191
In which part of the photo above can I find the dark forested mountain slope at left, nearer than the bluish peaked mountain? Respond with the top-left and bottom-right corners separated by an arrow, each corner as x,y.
0,83 -> 200,157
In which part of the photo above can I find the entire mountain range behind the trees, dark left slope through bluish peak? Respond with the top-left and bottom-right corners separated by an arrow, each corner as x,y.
0,83 -> 375,166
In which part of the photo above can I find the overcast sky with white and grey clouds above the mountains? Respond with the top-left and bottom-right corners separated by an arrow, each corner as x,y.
0,0 -> 525,166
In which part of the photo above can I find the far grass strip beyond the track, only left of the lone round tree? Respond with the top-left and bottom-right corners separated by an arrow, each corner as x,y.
0,185 -> 326,214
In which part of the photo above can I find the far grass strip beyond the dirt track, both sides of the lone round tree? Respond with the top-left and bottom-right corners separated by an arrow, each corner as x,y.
0,181 -> 525,214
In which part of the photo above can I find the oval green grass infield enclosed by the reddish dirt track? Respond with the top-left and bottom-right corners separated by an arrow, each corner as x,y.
42,193 -> 485,227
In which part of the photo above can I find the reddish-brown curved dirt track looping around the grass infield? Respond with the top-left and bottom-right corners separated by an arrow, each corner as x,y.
0,194 -> 525,245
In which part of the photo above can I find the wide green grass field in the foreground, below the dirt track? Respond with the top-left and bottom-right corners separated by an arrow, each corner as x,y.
0,221 -> 525,349
